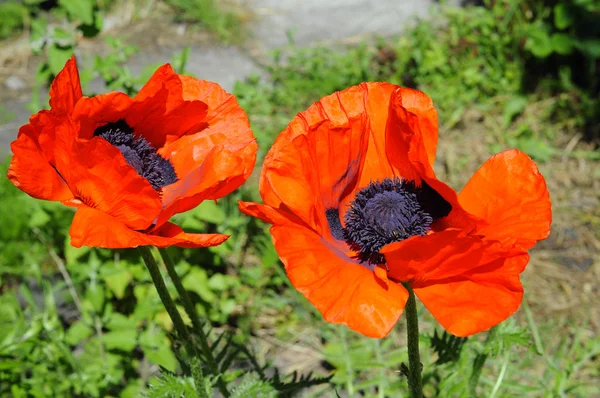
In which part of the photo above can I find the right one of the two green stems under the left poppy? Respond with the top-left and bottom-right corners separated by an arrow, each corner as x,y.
158,249 -> 229,397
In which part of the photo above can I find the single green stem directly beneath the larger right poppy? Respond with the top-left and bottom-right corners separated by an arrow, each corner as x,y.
403,283 -> 423,398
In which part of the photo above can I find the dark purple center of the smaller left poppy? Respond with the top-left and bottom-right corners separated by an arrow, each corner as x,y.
94,120 -> 177,190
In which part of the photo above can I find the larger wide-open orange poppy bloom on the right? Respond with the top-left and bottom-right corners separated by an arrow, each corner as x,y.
240,83 -> 551,337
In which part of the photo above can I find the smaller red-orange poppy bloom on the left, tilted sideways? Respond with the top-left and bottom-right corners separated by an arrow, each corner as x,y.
8,58 -> 257,248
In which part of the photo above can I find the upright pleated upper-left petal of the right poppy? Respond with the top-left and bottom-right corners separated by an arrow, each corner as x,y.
259,83 -> 380,234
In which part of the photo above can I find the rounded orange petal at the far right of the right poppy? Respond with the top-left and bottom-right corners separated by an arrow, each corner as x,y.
459,150 -> 552,251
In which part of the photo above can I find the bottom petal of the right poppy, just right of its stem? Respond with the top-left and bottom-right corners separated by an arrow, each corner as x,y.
414,253 -> 529,337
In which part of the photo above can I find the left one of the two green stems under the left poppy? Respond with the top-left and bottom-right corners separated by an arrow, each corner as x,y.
138,246 -> 208,398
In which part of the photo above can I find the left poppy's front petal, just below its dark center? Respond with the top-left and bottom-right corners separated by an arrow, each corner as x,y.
61,137 -> 161,230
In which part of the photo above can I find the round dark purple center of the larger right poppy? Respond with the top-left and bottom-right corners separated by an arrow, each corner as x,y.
325,178 -> 452,267
